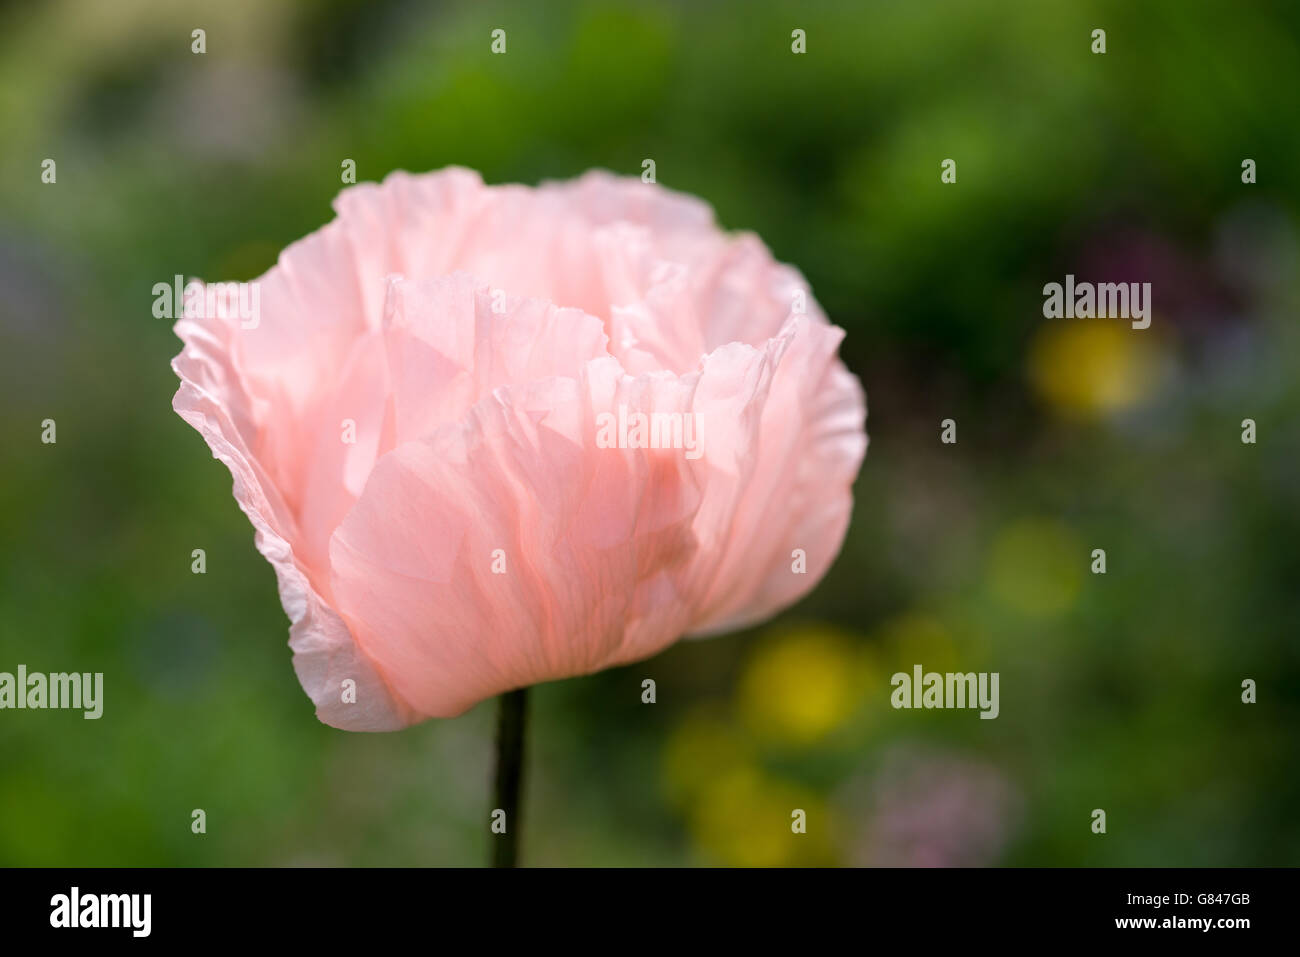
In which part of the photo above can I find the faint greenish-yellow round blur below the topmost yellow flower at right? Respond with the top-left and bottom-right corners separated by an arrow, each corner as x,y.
989,519 -> 1089,618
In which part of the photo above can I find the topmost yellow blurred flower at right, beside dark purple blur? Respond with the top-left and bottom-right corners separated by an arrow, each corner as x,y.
1028,319 -> 1162,419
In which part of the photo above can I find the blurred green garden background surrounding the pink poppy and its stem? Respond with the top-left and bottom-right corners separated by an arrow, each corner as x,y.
0,0 -> 1300,865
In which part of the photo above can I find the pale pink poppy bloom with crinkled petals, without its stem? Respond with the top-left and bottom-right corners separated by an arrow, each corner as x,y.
173,169 -> 867,731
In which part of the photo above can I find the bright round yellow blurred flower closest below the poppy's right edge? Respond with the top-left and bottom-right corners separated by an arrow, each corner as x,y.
737,625 -> 865,745
